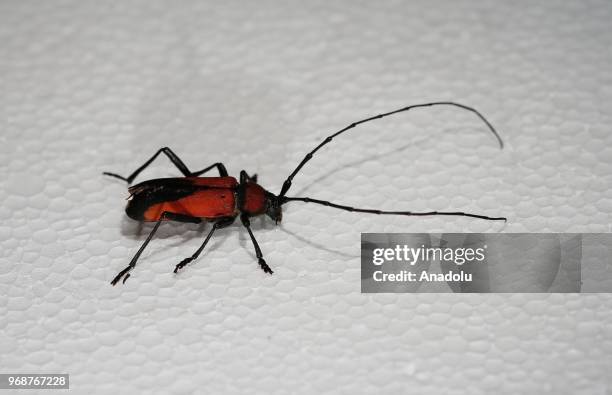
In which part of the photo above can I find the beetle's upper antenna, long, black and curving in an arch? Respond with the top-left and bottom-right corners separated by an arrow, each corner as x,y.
278,102 -> 504,198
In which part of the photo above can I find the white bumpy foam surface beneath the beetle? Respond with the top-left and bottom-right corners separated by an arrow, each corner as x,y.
0,1 -> 612,394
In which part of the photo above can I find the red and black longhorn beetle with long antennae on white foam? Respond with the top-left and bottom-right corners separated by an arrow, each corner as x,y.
103,101 -> 506,285
